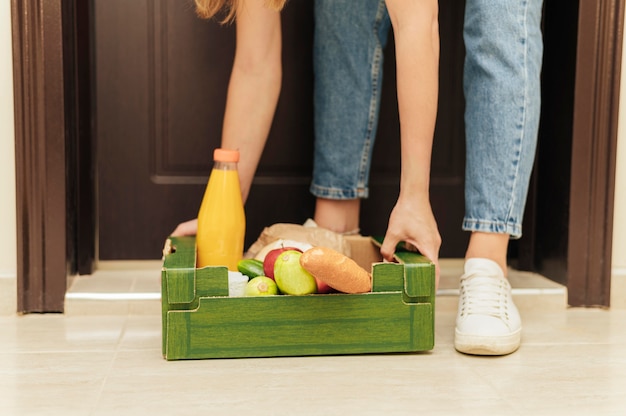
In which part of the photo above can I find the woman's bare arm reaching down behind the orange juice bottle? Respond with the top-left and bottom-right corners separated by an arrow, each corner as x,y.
171,0 -> 282,236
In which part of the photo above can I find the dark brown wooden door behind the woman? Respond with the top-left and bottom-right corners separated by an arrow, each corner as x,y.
94,0 -> 467,260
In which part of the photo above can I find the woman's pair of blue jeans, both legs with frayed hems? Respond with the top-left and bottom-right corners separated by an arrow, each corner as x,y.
310,0 -> 543,238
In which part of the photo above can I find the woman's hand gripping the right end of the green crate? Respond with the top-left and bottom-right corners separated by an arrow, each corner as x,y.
380,193 -> 441,288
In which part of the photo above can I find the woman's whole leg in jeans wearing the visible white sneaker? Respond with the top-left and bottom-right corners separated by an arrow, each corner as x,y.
455,0 -> 543,355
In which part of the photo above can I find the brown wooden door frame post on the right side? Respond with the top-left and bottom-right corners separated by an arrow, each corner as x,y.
567,0 -> 624,306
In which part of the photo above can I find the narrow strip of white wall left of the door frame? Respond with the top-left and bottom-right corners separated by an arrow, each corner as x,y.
0,1 -> 17,316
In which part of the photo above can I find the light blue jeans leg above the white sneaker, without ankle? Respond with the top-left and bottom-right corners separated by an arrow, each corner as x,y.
463,0 -> 543,250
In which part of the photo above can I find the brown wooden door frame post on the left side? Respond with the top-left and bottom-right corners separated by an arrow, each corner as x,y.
11,0 -> 96,313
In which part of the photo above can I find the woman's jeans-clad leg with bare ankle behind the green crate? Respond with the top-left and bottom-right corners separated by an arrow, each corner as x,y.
311,0 -> 390,232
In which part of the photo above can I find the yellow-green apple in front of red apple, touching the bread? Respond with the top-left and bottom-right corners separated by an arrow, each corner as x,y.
274,250 -> 317,295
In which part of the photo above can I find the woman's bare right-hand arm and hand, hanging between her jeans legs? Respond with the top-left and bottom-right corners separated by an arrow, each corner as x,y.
381,0 -> 441,284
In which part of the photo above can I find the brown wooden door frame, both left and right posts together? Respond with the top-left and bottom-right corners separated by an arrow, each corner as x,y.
11,0 -> 625,313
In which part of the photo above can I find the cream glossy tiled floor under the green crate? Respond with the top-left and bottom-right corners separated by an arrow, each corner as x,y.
0,260 -> 626,416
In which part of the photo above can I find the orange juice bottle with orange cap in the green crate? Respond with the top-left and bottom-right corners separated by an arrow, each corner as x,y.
196,149 -> 246,271
